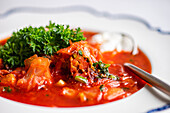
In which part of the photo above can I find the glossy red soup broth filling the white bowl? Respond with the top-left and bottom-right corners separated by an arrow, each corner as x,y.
0,32 -> 151,107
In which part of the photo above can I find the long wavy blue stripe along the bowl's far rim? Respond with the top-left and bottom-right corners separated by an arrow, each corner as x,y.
0,5 -> 170,35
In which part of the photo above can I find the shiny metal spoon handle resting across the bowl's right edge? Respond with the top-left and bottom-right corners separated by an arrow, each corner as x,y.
124,63 -> 170,96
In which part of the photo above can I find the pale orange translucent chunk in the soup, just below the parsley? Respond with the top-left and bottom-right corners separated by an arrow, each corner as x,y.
17,57 -> 52,91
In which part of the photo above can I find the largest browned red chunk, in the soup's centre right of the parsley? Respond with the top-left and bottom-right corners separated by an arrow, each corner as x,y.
55,41 -> 102,83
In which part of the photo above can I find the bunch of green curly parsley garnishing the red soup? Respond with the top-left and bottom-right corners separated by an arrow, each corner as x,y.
0,21 -> 86,68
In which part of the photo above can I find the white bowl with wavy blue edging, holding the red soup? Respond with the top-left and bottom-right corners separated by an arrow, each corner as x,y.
0,7 -> 170,113
